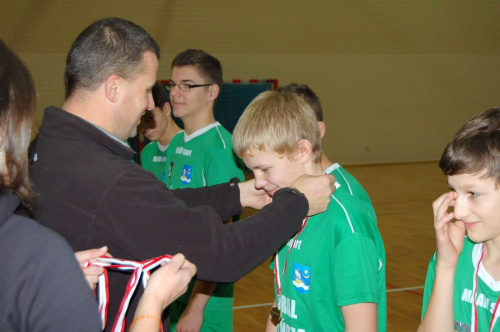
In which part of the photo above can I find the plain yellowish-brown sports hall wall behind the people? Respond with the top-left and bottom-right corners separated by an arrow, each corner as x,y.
0,0 -> 500,165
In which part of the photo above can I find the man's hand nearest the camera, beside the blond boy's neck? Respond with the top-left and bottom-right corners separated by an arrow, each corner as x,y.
290,174 -> 336,216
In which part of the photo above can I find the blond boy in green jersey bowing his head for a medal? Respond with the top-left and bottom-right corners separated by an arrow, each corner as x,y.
233,91 -> 387,332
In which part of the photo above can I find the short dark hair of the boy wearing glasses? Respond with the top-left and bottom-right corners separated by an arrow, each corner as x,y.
172,49 -> 222,87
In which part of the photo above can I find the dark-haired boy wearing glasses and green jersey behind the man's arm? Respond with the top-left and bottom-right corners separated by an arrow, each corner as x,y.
165,49 -> 244,331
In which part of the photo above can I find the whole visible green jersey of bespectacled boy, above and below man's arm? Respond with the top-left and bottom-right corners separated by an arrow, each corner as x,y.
165,122 -> 245,331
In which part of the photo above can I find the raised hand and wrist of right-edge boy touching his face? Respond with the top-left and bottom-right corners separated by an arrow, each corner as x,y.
432,191 -> 465,270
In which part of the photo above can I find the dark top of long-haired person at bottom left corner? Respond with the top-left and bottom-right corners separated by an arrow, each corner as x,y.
0,194 -> 101,332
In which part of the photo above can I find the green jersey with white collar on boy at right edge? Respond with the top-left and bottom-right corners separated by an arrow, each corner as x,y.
422,237 -> 500,332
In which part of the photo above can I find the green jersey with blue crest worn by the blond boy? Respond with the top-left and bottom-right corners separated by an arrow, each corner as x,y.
271,185 -> 387,332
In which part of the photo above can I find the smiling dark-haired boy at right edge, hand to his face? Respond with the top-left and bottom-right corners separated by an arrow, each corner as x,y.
419,108 -> 500,331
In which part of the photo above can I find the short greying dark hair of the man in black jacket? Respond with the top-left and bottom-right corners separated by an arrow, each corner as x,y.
64,17 -> 160,98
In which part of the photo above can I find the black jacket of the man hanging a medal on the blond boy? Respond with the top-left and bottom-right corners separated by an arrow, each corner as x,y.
31,107 -> 308,325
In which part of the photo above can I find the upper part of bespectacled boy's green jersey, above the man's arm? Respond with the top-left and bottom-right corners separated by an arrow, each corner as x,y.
165,122 -> 245,189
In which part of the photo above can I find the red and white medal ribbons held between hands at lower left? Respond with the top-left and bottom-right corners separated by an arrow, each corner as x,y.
84,255 -> 172,332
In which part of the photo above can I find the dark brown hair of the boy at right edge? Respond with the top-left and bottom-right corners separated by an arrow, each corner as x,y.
439,107 -> 500,185
